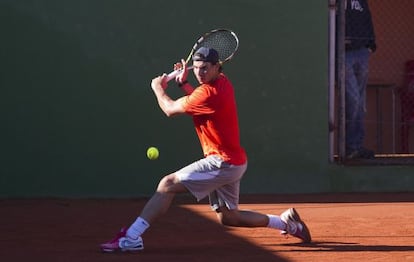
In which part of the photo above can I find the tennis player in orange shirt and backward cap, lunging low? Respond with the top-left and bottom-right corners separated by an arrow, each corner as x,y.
101,47 -> 311,252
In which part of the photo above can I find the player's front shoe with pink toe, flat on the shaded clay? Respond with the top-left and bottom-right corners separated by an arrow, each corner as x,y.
100,228 -> 144,253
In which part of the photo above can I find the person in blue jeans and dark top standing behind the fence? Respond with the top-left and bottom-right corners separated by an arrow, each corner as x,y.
345,0 -> 376,159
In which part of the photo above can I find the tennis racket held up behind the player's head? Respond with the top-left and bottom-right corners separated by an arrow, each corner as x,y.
167,29 -> 239,82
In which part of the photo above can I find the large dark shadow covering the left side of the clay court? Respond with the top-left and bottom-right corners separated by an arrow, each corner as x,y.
0,199 -> 288,262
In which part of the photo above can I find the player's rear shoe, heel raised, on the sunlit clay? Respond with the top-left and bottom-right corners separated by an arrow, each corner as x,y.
280,208 -> 312,243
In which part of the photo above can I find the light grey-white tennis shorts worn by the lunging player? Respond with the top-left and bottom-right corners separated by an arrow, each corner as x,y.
175,155 -> 247,210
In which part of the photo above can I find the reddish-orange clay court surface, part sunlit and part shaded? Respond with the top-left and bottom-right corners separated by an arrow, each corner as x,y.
0,193 -> 414,262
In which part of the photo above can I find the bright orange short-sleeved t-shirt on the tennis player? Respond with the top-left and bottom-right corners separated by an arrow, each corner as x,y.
183,74 -> 247,165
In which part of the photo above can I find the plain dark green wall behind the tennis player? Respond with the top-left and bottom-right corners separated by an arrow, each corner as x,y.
0,0 -> 414,197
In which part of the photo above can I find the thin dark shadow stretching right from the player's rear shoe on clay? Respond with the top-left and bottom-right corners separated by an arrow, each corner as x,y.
276,241 -> 414,252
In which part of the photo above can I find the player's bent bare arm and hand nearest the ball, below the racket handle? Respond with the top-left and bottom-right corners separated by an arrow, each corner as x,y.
151,75 -> 185,116
